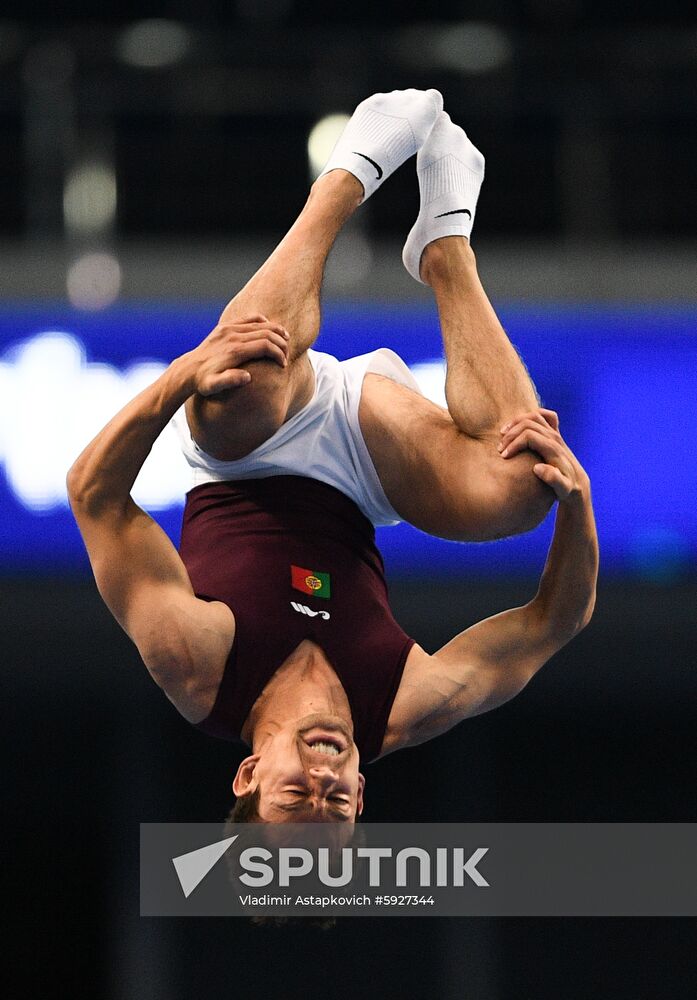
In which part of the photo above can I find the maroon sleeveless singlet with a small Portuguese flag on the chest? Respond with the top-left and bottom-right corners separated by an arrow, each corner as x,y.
180,476 -> 414,761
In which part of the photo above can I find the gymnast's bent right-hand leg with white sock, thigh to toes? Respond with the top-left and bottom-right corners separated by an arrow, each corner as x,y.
360,113 -> 553,540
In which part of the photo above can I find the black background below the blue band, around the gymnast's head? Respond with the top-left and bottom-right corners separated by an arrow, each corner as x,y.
6,579 -> 697,1000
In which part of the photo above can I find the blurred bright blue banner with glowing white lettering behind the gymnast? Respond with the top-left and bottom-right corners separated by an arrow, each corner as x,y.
0,302 -> 697,582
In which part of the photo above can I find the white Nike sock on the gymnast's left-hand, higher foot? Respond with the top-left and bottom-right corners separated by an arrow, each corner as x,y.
320,90 -> 443,201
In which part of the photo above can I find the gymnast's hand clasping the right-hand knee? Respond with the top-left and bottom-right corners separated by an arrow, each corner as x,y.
499,409 -> 590,503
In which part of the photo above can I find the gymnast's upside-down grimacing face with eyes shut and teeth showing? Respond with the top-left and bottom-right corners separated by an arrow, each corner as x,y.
232,715 -> 365,824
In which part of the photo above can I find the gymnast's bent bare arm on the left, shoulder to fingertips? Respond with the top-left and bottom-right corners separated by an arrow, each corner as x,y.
67,316 -> 287,702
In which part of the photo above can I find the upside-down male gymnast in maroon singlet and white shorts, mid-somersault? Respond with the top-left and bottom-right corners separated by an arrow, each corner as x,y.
67,90 -> 597,823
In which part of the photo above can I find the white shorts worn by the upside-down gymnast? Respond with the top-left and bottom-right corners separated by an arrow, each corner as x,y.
172,347 -> 421,525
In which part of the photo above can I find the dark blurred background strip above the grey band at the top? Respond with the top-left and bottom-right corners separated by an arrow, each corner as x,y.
0,0 -> 697,239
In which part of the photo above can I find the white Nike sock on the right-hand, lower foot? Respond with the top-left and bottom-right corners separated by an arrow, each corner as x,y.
402,111 -> 484,284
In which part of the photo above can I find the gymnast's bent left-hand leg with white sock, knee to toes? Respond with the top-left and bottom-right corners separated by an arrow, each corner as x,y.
186,90 -> 443,460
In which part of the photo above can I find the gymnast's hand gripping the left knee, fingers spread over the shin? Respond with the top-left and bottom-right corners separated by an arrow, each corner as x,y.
186,315 -> 289,396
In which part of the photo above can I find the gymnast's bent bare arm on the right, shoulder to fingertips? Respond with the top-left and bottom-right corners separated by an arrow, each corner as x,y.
384,410 -> 598,752
